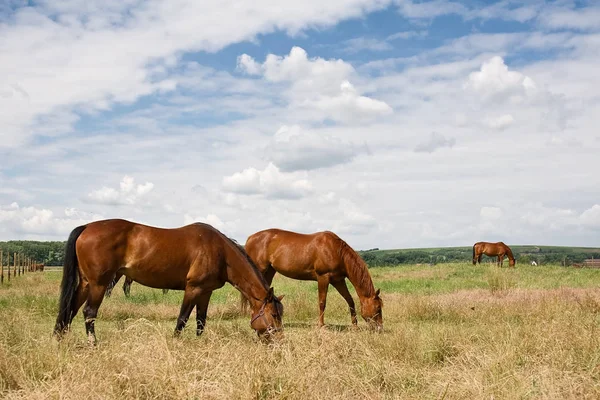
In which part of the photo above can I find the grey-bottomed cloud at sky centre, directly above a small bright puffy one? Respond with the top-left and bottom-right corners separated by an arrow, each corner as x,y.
266,125 -> 367,172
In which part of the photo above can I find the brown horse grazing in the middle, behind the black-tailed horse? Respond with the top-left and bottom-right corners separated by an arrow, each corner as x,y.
242,229 -> 383,331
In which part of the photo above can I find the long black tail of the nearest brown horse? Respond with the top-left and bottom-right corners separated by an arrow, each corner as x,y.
54,225 -> 86,335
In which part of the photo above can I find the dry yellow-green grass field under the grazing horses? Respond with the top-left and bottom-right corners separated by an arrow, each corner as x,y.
0,263 -> 600,399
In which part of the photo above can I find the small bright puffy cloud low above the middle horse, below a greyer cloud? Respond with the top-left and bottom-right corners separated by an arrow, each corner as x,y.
223,163 -> 312,199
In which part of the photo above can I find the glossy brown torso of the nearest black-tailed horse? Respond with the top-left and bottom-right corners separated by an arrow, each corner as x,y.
76,219 -> 223,289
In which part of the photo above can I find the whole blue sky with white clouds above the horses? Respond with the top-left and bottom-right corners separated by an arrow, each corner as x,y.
0,0 -> 600,249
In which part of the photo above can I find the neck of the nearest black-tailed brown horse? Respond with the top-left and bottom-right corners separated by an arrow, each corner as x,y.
226,247 -> 269,308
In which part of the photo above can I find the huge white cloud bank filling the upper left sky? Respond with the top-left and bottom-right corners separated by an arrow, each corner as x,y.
0,0 -> 394,146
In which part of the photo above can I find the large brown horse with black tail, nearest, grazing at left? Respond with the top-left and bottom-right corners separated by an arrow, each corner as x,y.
54,219 -> 283,344
